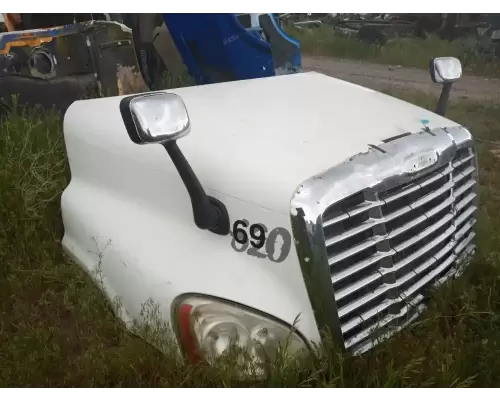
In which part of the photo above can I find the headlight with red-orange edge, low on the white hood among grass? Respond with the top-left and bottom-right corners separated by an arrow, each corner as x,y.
174,296 -> 308,374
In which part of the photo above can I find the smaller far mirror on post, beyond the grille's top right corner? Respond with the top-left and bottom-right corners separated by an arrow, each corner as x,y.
429,57 -> 462,116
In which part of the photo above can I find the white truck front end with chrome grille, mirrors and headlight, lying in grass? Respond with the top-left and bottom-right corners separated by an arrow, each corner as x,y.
61,58 -> 477,370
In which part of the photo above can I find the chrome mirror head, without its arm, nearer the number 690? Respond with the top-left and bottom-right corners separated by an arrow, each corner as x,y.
120,92 -> 190,144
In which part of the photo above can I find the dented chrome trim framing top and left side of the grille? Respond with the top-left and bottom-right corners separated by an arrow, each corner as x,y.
290,126 -> 477,349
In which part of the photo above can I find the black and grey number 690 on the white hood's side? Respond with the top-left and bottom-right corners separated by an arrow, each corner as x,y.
231,219 -> 292,263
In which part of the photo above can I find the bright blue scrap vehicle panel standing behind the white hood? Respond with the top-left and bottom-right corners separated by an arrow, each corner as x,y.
164,14 -> 302,84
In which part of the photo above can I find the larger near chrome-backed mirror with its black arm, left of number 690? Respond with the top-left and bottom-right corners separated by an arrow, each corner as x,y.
120,92 -> 230,235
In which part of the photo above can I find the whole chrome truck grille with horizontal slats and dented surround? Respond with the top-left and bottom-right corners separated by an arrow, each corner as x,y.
290,127 -> 477,353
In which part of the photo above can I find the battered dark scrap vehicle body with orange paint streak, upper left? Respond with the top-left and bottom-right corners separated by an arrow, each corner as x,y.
0,21 -> 148,111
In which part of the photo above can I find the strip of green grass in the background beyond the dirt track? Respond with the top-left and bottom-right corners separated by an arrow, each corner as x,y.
287,26 -> 500,77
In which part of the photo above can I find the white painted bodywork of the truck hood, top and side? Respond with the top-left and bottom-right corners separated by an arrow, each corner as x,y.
61,73 -> 462,354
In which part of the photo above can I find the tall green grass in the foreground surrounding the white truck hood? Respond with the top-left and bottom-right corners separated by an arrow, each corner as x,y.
0,91 -> 500,387
